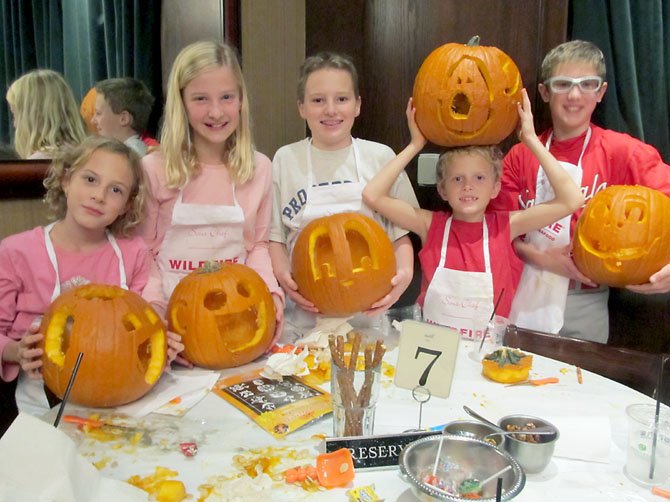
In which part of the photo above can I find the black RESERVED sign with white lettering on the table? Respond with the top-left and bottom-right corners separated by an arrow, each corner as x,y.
326,431 -> 442,469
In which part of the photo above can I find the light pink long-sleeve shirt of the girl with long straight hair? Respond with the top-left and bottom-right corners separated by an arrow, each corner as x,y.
139,151 -> 284,312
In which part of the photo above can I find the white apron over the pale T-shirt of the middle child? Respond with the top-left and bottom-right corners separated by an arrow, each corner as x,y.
287,138 -> 381,330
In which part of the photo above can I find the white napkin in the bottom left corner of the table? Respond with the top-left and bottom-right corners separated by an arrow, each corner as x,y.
0,413 -> 149,502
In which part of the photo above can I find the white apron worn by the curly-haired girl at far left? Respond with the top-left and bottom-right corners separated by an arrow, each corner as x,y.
15,222 -> 128,416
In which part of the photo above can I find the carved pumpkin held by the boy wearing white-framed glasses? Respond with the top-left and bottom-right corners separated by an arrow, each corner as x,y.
573,185 -> 670,287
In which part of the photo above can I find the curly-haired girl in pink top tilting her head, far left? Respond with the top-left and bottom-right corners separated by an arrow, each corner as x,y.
0,137 -> 183,414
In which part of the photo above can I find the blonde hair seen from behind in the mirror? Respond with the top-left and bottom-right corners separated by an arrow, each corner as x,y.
6,70 -> 86,158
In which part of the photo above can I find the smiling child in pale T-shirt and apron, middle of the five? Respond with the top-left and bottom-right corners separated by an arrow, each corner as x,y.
270,52 -> 418,334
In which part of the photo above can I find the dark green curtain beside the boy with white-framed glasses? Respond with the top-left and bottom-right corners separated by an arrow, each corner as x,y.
570,0 -> 670,162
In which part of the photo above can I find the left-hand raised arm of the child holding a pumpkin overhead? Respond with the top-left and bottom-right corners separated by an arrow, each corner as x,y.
363,98 -> 432,242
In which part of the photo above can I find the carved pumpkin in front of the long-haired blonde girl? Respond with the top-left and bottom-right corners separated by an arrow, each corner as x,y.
168,263 -> 276,370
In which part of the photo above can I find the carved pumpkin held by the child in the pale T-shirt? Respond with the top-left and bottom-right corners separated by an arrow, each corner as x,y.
291,213 -> 396,316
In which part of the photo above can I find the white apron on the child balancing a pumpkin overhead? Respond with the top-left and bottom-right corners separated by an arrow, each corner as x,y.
423,216 -> 493,339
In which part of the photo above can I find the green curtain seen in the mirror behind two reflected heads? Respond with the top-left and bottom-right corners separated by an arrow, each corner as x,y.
0,0 -> 163,143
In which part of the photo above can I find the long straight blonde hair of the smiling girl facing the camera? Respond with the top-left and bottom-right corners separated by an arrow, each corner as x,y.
161,42 -> 255,188
